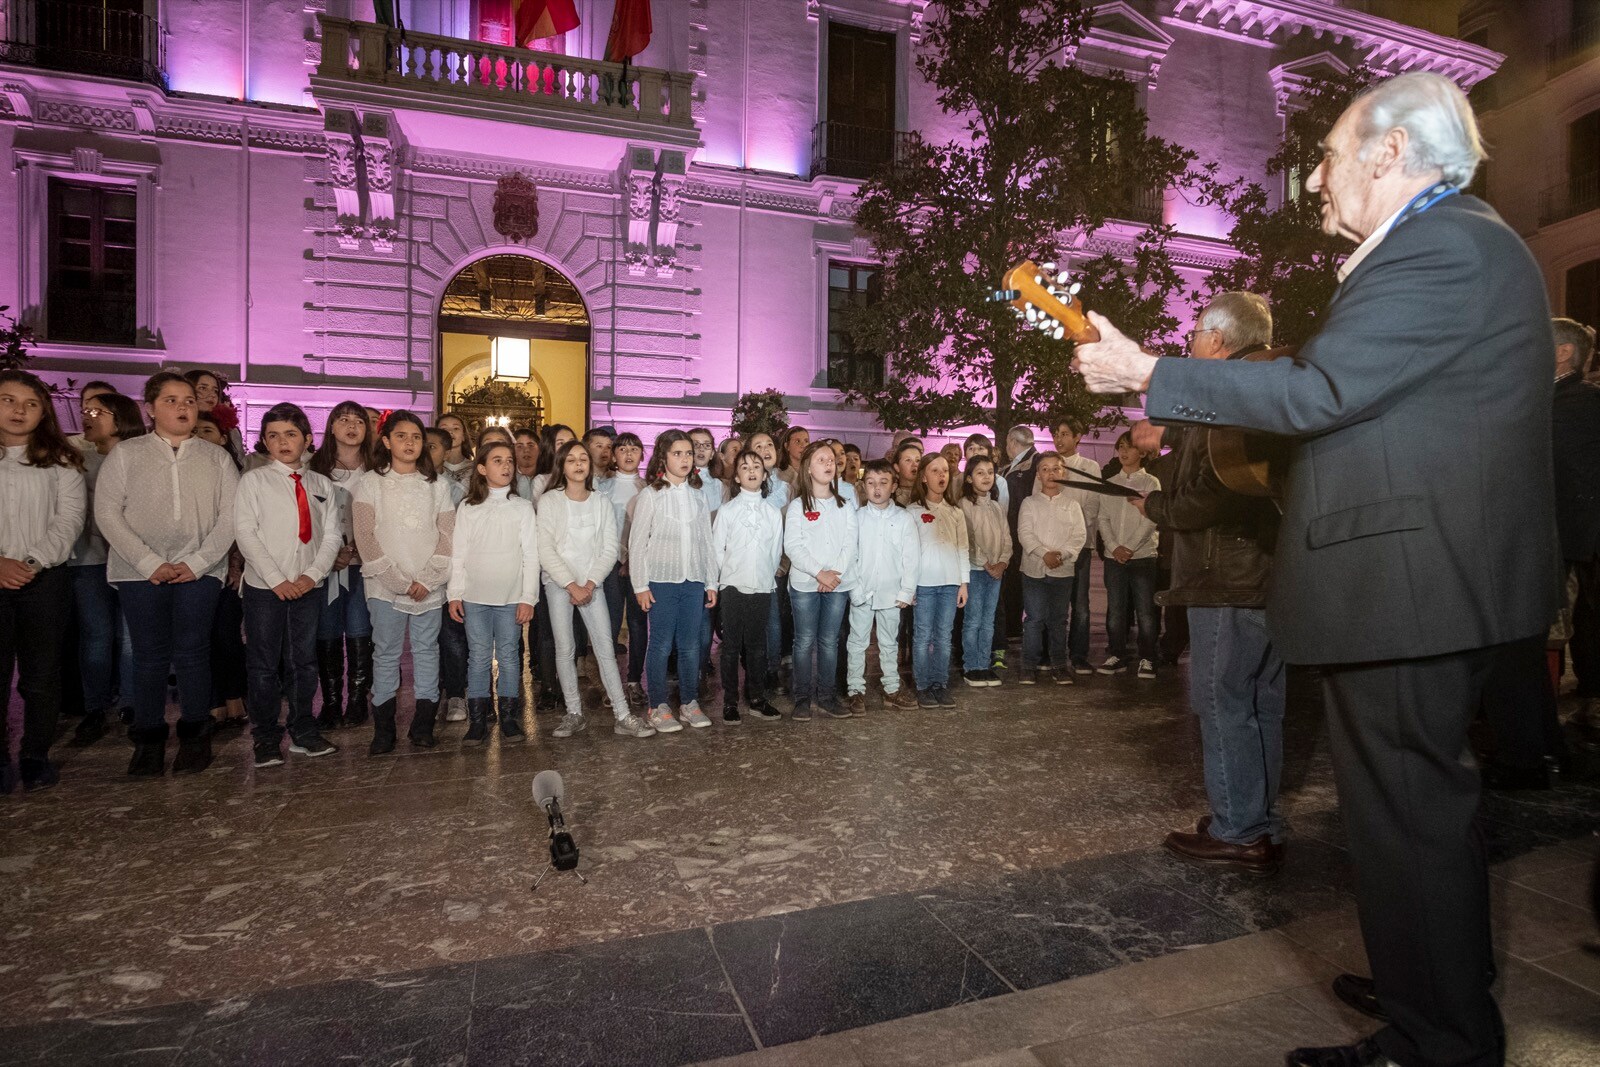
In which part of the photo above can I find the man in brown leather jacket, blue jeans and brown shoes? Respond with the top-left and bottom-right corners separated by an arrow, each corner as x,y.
1131,293 -> 1283,873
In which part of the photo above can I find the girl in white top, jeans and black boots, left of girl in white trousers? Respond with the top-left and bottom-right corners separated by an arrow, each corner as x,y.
450,440 -> 539,745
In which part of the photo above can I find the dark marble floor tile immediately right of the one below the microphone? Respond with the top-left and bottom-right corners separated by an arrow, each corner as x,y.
712,896 -> 1010,1045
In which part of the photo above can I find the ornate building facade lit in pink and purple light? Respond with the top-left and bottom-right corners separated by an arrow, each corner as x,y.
0,0 -> 1501,446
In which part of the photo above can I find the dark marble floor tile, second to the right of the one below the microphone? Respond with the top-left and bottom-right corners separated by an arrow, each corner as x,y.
920,857 -> 1246,989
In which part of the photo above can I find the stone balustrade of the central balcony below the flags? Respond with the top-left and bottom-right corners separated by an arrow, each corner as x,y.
317,14 -> 694,130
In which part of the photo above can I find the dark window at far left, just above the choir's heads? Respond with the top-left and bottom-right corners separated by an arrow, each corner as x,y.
46,181 -> 136,344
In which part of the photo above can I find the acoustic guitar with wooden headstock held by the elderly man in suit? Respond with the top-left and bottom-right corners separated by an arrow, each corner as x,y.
990,259 -> 1299,499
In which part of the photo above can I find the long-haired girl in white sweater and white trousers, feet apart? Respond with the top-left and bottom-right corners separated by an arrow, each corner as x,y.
539,442 -> 656,737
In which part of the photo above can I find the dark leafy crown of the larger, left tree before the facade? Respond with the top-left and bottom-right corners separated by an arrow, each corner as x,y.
845,0 -> 1194,435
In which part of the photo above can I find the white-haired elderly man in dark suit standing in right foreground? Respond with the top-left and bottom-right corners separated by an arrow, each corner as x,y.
1077,74 -> 1560,1067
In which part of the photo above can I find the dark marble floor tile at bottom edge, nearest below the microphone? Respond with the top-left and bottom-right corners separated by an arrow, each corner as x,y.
467,929 -> 755,1067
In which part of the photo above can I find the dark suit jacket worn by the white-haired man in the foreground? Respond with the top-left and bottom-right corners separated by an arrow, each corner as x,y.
1147,195 -> 1560,664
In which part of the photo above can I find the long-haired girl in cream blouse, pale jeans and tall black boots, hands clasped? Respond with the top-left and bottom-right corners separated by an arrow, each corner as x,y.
352,411 -> 456,755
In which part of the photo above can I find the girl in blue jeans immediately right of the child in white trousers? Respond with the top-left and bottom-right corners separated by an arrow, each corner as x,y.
906,453 -> 971,707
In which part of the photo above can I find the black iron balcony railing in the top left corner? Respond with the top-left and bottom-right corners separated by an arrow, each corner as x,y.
0,0 -> 166,88
